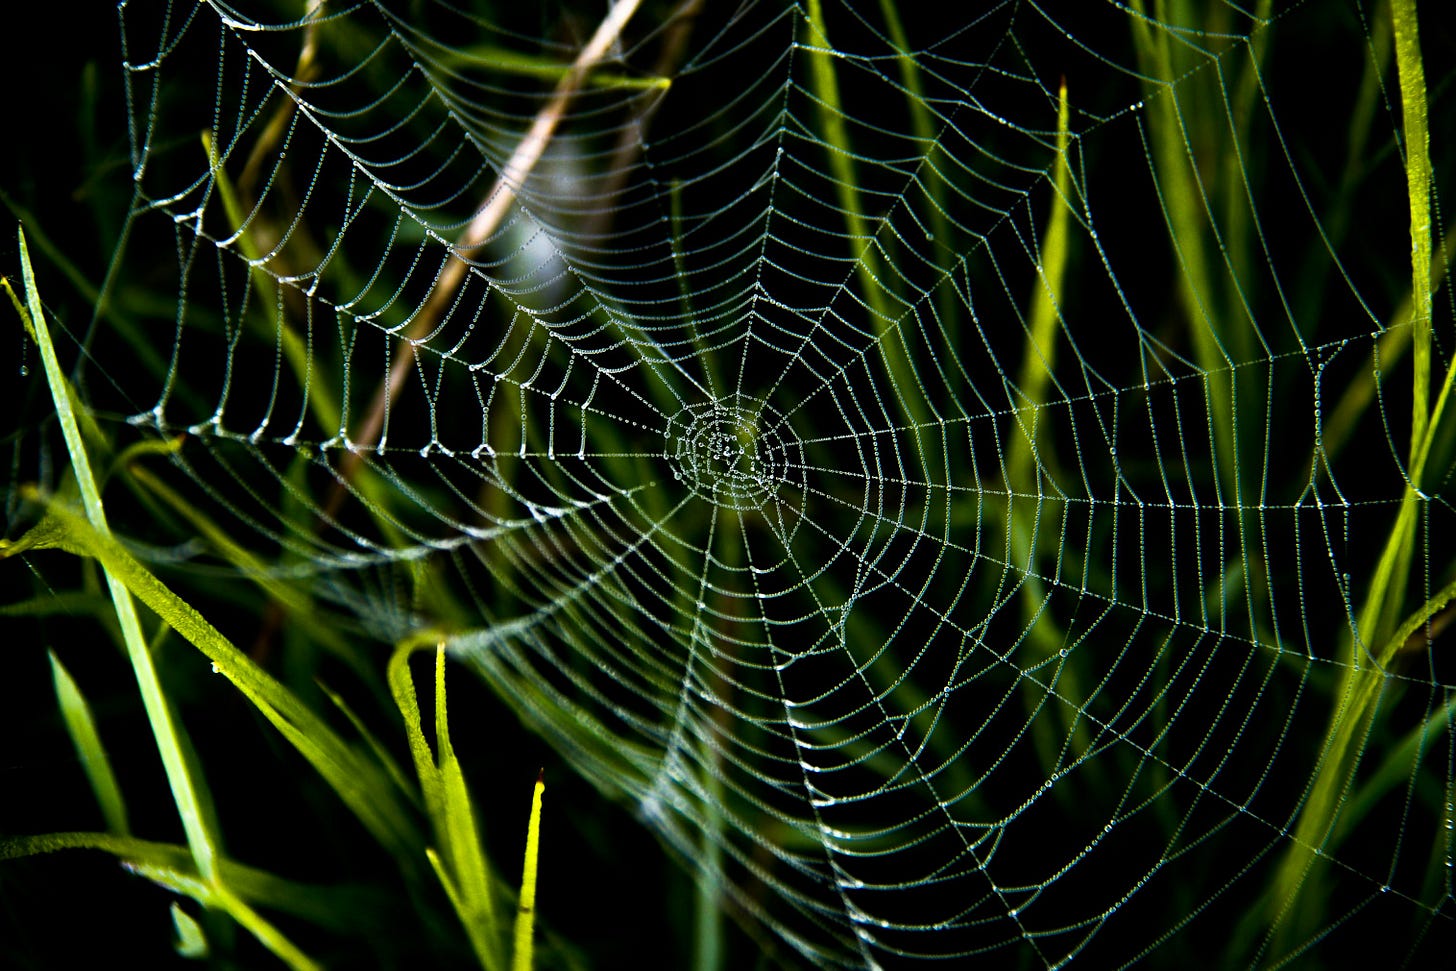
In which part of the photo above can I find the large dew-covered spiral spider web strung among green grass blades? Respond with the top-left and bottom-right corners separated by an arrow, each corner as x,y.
96,0 -> 1456,967
